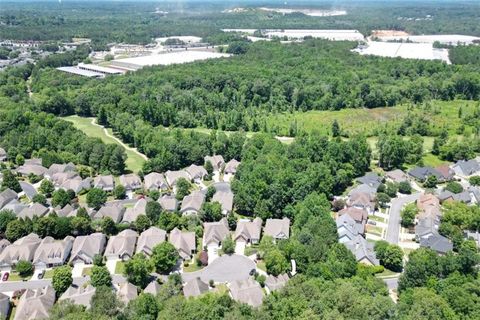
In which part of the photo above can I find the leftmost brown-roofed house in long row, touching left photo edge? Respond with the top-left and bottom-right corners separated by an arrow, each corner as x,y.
0,233 -> 42,267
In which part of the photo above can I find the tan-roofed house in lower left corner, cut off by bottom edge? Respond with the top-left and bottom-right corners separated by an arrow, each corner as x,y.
14,286 -> 55,320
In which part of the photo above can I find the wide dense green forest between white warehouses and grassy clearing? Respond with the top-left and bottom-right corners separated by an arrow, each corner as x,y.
33,40 -> 480,131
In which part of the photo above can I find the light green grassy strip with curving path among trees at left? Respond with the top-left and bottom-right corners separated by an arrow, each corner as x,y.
63,116 -> 145,172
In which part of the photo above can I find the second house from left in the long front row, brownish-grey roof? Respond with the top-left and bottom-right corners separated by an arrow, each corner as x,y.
33,236 -> 75,268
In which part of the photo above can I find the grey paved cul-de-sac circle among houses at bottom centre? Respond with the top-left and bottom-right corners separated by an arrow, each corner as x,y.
182,254 -> 256,283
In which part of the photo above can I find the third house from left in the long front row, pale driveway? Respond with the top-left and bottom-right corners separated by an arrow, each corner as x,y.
70,232 -> 107,264
